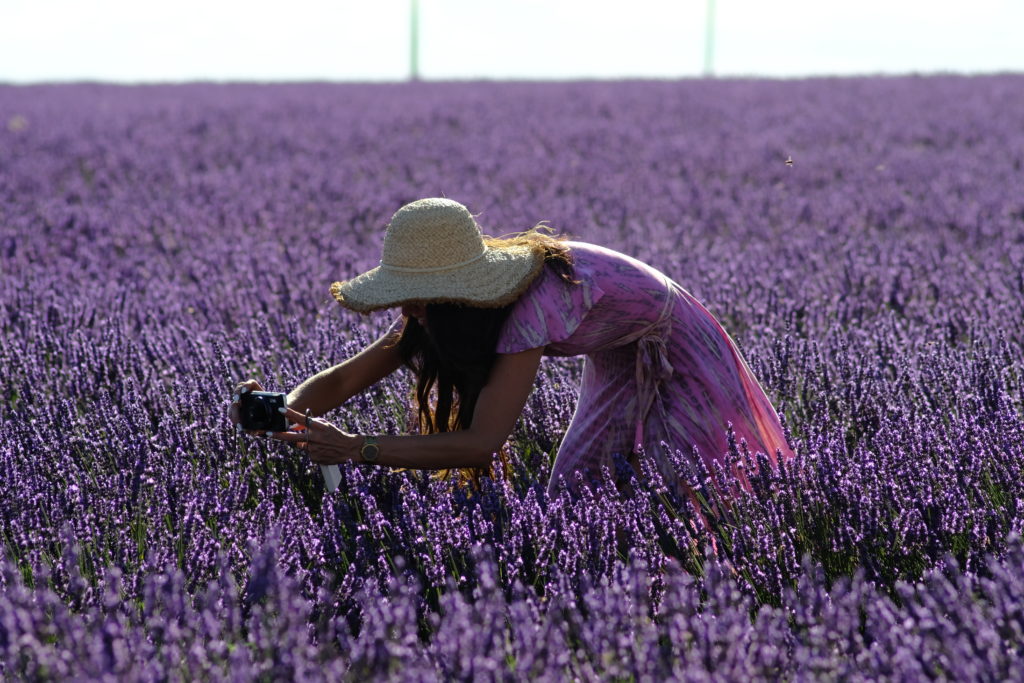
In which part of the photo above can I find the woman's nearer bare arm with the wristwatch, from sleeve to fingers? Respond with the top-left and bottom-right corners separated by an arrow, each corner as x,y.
273,347 -> 544,470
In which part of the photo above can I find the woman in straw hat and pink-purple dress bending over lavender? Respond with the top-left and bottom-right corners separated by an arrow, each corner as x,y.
230,199 -> 792,501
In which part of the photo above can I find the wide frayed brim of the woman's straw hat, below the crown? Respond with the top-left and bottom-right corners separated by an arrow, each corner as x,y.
331,245 -> 544,313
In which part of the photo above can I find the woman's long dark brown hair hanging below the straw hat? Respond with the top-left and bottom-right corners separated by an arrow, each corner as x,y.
398,224 -> 577,487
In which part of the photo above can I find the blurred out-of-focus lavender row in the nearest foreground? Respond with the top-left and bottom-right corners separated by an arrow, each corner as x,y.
8,537 -> 1024,681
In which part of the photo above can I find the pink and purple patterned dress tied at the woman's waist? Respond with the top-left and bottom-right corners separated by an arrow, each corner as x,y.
498,242 -> 793,494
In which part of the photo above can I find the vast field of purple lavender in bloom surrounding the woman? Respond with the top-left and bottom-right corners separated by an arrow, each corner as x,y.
0,76 -> 1024,681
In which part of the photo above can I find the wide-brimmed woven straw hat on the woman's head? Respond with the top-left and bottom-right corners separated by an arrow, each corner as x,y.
331,198 -> 544,313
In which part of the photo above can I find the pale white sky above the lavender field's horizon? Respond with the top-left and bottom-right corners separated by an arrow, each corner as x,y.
0,0 -> 1024,83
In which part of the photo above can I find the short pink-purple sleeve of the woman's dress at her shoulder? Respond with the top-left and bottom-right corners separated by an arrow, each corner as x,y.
497,267 -> 604,353
